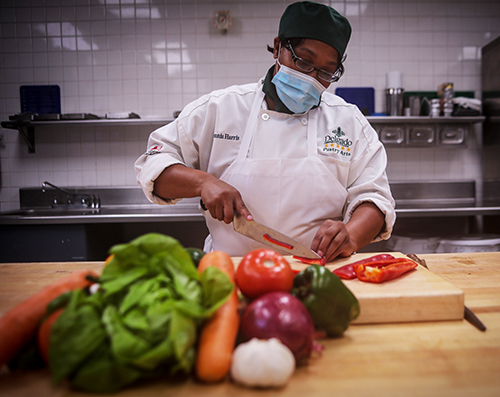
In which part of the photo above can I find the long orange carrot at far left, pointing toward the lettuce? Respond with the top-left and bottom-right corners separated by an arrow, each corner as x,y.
0,270 -> 98,367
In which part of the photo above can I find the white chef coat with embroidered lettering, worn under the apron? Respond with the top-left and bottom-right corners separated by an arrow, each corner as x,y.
135,80 -> 396,254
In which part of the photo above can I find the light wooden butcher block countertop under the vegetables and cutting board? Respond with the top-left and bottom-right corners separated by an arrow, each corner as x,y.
0,252 -> 500,397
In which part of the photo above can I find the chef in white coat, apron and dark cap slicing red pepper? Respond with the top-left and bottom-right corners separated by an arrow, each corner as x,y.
135,1 -> 395,261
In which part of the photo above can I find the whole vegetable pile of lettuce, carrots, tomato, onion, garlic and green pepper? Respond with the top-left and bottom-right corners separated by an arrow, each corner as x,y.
0,233 -> 368,393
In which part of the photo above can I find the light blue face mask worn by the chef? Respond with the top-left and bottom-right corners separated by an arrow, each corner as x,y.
272,61 -> 326,113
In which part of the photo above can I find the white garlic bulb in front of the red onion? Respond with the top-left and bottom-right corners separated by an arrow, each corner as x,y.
231,338 -> 295,387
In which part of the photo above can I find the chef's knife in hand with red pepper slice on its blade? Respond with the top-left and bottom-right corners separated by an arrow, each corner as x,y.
200,200 -> 321,259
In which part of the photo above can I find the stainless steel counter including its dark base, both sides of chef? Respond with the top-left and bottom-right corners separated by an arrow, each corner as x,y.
0,181 -> 500,262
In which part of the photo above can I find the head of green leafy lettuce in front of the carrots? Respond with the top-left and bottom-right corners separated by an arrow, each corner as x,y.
49,233 -> 234,392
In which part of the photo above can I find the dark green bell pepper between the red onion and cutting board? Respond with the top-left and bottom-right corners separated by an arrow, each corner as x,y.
292,265 -> 360,337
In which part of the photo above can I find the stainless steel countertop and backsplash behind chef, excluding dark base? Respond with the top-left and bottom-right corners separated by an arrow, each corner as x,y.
0,181 -> 500,225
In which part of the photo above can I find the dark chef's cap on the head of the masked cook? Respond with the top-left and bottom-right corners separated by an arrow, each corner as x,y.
278,1 -> 351,57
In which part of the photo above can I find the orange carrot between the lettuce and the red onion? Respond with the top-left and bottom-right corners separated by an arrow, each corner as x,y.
195,251 -> 240,382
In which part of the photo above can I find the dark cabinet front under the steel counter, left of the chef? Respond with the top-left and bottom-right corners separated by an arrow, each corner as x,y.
0,220 -> 208,263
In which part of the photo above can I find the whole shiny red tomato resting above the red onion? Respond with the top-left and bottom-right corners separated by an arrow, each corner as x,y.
236,248 -> 294,299
